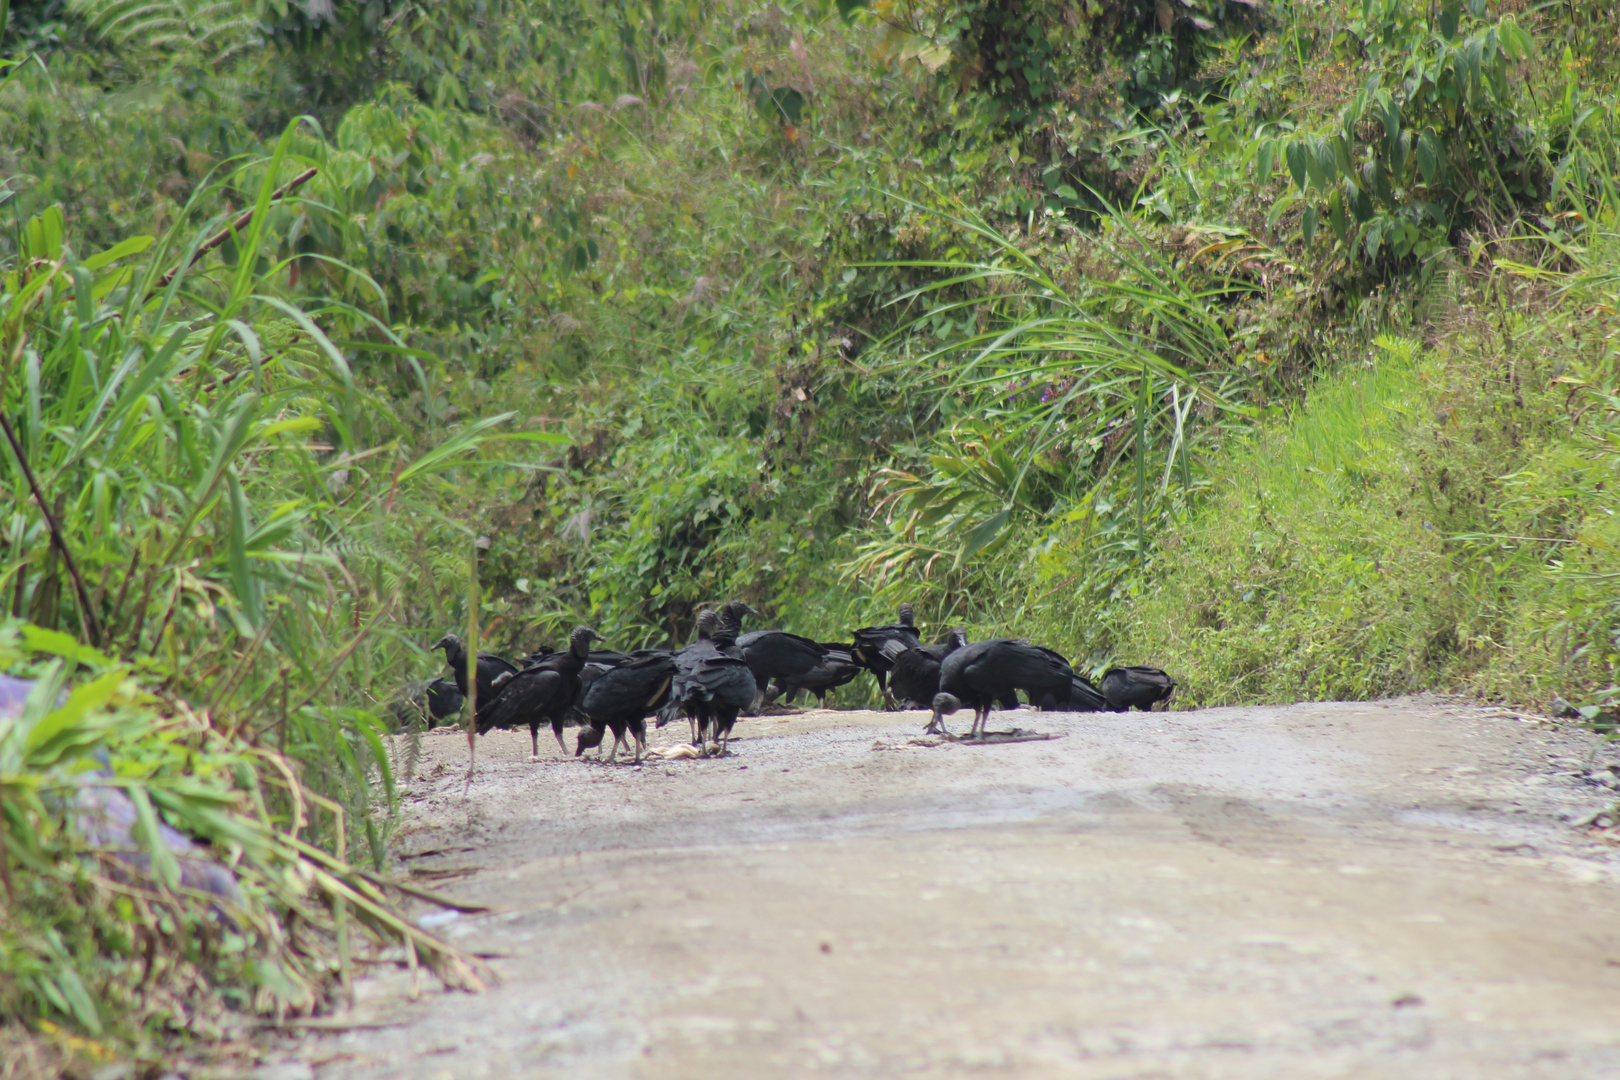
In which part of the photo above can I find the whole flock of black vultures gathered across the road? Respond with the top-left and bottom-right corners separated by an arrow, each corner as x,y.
423,601 -> 1176,774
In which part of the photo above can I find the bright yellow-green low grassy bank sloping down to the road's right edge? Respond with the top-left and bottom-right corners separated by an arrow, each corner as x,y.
1116,265 -> 1620,706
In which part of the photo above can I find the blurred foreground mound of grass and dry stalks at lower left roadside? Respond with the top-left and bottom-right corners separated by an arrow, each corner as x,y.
0,620 -> 481,1074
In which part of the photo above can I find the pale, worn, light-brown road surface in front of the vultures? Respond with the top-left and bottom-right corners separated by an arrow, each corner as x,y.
295,699 -> 1620,1080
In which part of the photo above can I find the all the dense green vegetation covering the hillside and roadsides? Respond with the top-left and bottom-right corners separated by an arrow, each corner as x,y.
0,0 -> 1620,1072
